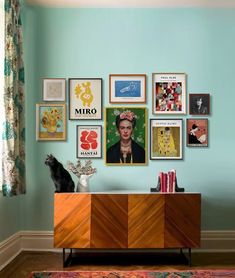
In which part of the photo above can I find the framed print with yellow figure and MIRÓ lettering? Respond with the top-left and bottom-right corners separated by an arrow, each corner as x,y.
69,78 -> 102,120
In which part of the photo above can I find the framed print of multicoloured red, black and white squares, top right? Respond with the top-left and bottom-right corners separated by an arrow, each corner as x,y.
153,73 -> 186,114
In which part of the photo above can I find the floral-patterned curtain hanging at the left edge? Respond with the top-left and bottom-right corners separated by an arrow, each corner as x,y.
2,0 -> 25,196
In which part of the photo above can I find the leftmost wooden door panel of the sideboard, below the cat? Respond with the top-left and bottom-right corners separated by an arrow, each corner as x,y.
54,193 -> 91,248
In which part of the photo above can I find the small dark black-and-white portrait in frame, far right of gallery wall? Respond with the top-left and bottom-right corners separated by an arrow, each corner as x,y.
189,94 -> 210,115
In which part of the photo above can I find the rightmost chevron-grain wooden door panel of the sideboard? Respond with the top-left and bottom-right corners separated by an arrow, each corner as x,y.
164,194 -> 201,248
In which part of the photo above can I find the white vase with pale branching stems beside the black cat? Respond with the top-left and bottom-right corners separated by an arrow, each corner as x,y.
67,160 -> 96,192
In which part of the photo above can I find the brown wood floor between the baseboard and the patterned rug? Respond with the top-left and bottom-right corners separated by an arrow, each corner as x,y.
0,252 -> 235,278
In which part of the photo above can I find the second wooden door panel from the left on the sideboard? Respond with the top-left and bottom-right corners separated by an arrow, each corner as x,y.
91,194 -> 128,248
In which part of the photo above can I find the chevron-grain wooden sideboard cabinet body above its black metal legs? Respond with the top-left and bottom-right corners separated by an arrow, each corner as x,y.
54,193 -> 201,250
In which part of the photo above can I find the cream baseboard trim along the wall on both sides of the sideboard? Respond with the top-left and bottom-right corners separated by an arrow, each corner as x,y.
0,230 -> 235,270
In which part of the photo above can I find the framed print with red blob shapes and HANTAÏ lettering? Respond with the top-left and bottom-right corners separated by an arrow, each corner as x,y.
77,125 -> 102,158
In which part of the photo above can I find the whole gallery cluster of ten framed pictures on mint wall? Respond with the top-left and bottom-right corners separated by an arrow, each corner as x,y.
36,73 -> 210,165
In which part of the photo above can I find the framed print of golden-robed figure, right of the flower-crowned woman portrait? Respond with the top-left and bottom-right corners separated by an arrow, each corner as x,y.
150,119 -> 183,159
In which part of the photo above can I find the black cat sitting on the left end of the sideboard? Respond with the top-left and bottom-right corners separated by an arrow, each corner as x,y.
45,154 -> 75,192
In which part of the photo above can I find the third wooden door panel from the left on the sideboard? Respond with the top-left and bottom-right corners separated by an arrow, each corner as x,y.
128,194 -> 164,248
